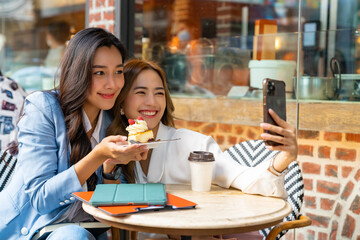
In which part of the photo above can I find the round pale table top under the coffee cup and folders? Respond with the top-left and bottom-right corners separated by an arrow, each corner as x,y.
83,185 -> 291,235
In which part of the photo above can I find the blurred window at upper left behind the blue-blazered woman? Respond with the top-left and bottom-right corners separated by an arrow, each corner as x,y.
0,0 -> 85,92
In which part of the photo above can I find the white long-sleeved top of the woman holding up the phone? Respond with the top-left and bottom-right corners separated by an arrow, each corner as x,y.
135,123 -> 287,199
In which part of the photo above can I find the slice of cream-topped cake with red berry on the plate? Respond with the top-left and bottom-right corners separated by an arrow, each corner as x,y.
126,117 -> 154,143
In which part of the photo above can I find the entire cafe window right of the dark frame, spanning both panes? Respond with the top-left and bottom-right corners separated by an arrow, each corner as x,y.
135,0 -> 360,100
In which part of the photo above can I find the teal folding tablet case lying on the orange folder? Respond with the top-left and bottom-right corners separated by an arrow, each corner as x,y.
90,183 -> 167,206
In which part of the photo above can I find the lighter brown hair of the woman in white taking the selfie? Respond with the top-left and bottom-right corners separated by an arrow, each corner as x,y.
108,59 -> 175,183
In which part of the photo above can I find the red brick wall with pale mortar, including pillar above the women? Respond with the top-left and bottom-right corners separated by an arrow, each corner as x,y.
89,0 -> 360,240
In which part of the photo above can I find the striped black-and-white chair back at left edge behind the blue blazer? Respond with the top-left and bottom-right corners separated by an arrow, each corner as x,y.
0,150 -> 17,192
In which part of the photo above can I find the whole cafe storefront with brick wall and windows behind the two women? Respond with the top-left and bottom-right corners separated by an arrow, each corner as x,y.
0,0 -> 360,239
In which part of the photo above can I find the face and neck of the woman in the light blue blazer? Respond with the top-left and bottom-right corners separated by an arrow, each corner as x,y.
83,46 -> 124,121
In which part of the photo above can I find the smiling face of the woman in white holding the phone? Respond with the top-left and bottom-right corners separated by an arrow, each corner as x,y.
122,69 -> 166,136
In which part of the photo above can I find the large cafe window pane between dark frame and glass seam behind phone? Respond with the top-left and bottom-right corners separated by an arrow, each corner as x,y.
135,0 -> 298,97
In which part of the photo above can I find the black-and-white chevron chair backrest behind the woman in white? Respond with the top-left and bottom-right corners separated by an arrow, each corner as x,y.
225,140 -> 304,239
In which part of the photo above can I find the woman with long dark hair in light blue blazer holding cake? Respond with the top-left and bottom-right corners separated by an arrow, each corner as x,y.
0,28 -> 147,239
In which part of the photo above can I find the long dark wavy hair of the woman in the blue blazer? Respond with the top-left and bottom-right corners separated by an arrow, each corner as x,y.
58,28 -> 127,190
